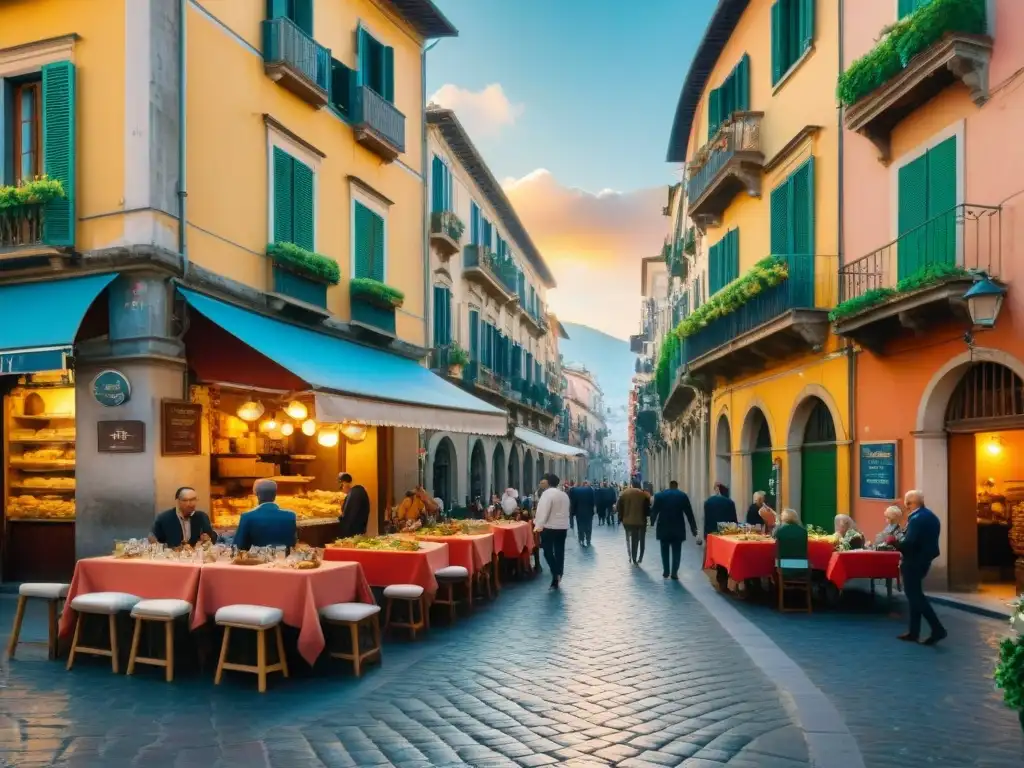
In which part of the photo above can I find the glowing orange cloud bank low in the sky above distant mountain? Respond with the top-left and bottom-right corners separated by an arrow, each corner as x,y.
504,169 -> 668,339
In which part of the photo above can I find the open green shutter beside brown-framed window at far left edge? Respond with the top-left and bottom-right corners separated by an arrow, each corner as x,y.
42,61 -> 77,247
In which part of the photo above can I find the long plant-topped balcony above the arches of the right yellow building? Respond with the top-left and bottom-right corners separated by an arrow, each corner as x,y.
684,254 -> 839,388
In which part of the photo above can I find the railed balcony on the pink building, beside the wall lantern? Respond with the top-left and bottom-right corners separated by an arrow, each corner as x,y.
831,204 -> 1002,349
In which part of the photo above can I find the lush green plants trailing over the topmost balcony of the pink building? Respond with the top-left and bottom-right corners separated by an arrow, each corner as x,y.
836,0 -> 988,106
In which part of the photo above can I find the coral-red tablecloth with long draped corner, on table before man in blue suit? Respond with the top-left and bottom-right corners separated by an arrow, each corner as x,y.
193,562 -> 374,666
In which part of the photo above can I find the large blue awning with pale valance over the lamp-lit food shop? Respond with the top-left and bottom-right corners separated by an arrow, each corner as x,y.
178,288 -> 508,435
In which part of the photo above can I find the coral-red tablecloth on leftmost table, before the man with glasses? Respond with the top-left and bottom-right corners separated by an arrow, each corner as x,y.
59,556 -> 203,635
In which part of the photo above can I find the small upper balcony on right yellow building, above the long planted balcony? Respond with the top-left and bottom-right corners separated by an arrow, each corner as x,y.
686,112 -> 765,227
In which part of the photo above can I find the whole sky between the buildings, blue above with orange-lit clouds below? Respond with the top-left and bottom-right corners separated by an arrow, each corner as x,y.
427,0 -> 716,339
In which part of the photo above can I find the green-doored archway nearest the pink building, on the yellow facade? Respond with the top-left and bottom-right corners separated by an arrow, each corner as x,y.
798,397 -> 839,532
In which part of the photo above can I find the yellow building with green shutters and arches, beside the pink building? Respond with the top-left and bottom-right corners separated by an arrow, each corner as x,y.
666,0 -> 851,527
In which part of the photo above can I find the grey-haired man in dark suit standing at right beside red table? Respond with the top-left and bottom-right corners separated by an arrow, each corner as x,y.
898,490 -> 947,645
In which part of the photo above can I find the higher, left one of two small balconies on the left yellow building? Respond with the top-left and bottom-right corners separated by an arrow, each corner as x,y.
263,17 -> 331,109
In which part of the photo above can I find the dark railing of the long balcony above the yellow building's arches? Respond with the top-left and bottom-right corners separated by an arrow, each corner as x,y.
685,254 -> 839,362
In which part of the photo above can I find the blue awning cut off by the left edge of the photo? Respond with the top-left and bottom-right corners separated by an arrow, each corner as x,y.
0,274 -> 117,374
